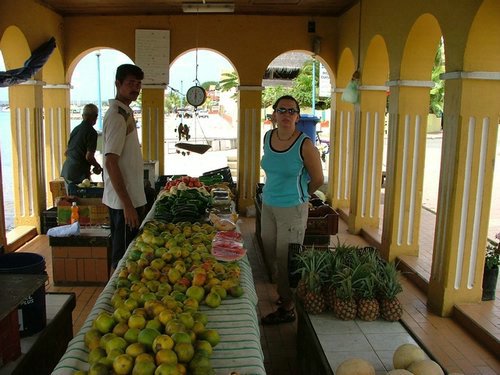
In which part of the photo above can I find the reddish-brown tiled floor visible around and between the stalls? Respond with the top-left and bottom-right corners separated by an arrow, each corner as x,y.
13,214 -> 500,375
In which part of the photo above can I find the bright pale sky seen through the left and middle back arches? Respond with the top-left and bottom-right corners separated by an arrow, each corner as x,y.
0,49 -> 233,102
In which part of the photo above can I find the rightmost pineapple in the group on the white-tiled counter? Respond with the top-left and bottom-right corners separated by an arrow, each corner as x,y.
379,262 -> 403,322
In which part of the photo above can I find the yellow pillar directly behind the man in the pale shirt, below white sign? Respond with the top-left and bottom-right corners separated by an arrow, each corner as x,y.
141,86 -> 165,176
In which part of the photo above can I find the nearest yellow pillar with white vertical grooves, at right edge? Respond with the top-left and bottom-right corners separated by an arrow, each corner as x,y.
428,72 -> 500,316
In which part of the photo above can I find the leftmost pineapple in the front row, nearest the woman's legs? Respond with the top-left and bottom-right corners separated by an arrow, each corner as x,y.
297,249 -> 329,314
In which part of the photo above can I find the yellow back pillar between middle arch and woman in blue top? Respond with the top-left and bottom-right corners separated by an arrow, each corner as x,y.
238,86 -> 263,213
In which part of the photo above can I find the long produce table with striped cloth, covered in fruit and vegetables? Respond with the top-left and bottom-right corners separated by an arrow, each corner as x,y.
53,176 -> 265,375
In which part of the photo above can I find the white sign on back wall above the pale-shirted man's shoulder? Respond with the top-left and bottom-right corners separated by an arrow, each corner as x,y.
135,30 -> 170,86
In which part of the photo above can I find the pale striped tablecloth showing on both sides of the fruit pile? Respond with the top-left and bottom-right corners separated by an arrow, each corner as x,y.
52,206 -> 266,375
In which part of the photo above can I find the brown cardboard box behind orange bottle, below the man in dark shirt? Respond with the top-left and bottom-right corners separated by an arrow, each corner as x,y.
57,197 -> 109,225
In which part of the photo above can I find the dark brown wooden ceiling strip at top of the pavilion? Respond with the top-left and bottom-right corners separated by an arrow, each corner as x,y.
37,0 -> 359,17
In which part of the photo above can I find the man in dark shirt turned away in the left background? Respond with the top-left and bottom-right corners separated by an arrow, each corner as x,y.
61,104 -> 102,195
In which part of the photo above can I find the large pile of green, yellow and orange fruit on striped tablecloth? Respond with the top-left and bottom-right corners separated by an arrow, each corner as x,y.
79,221 -> 243,375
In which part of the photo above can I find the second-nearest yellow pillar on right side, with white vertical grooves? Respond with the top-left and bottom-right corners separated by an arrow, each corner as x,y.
382,81 -> 433,260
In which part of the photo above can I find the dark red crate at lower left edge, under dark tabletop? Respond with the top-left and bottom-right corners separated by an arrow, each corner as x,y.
0,309 -> 21,367
